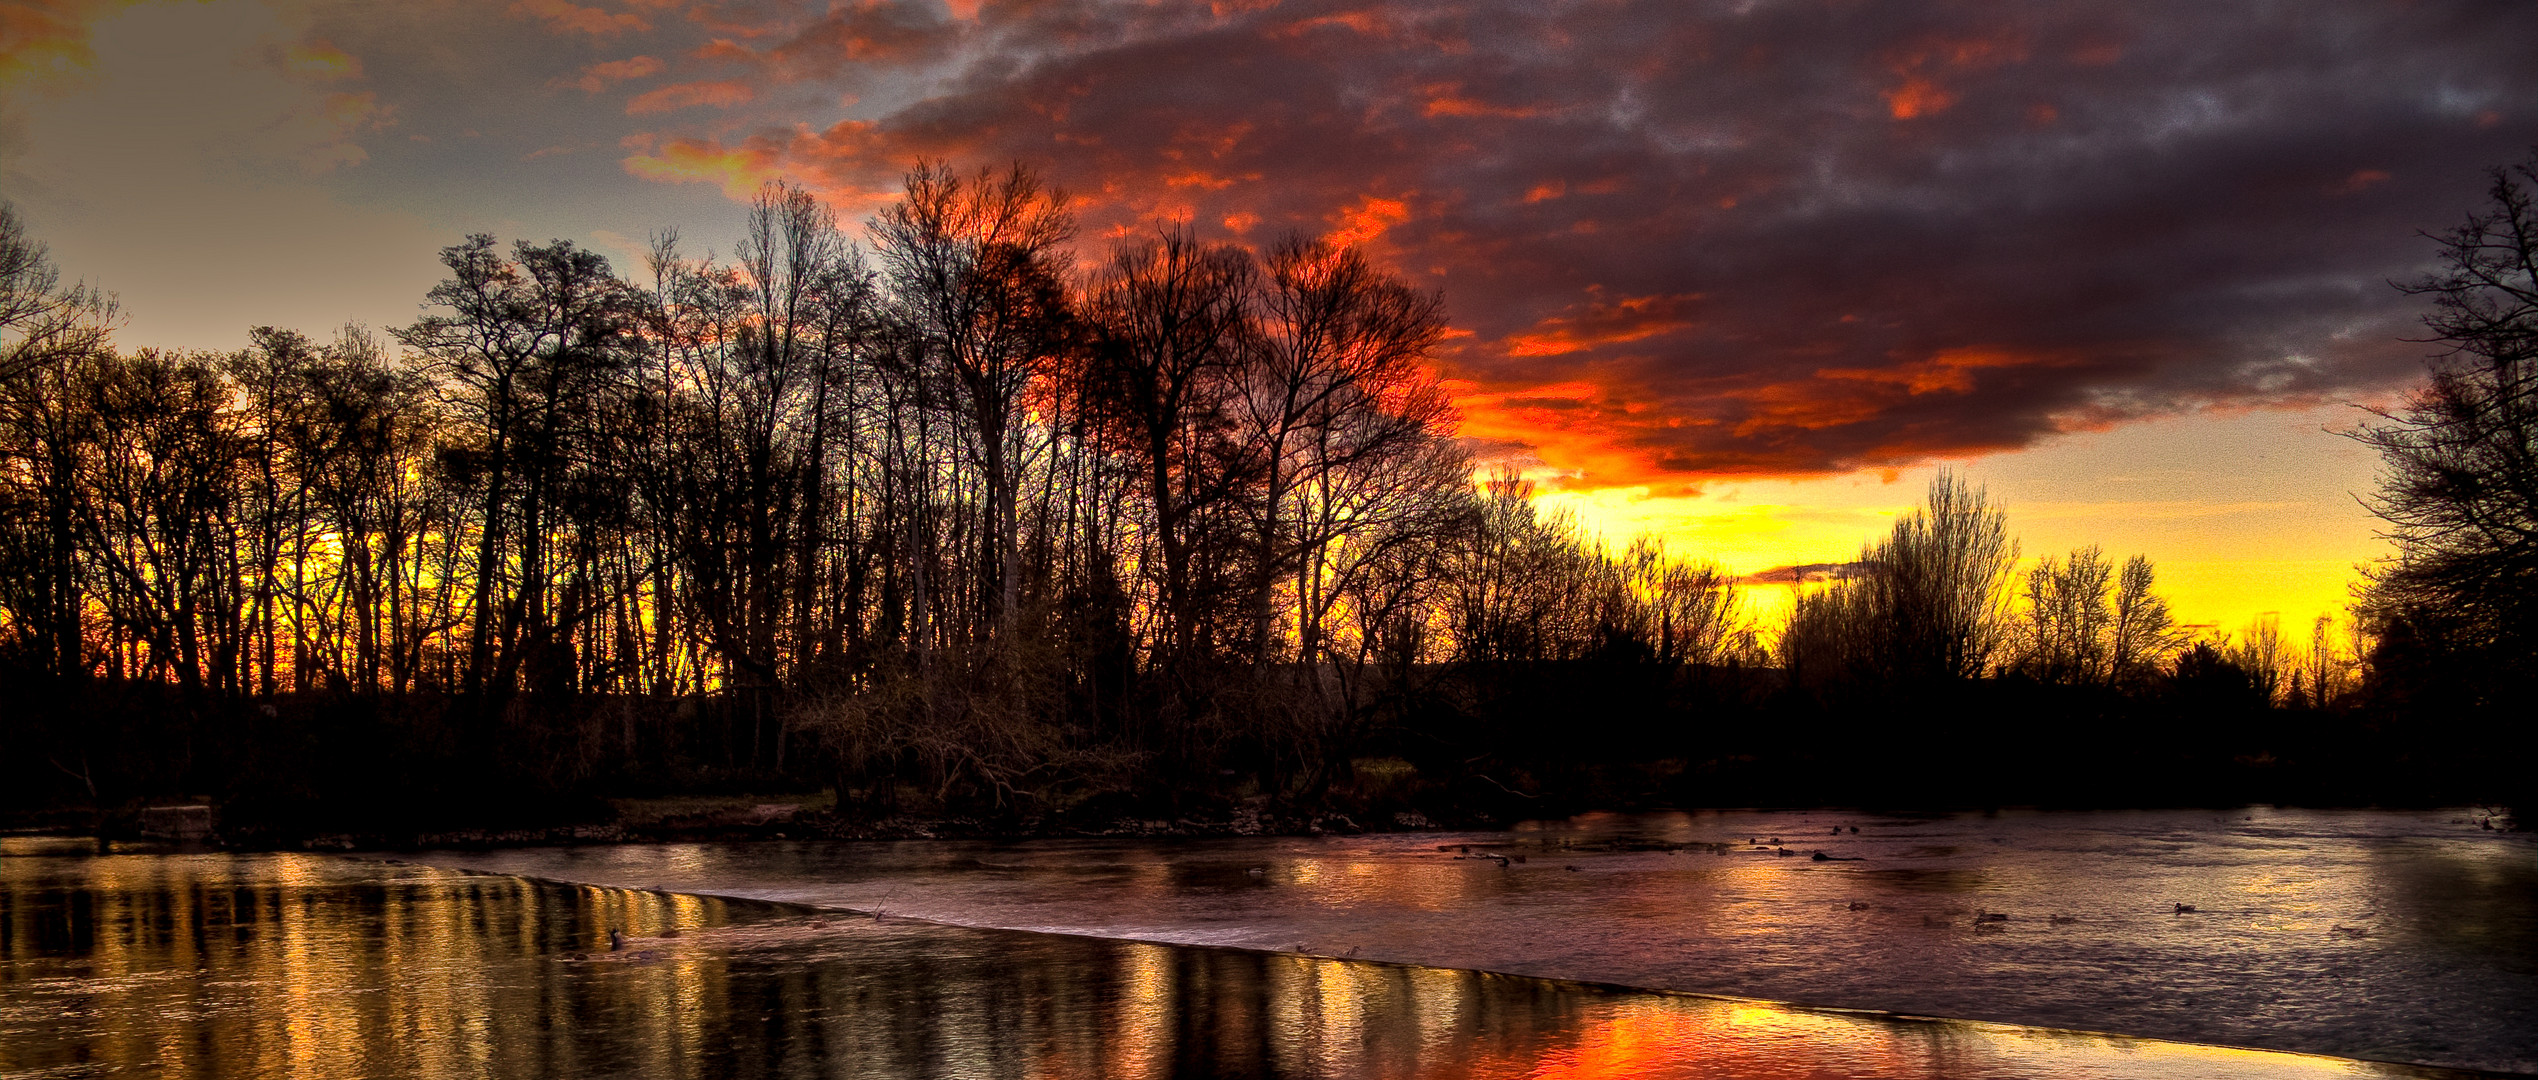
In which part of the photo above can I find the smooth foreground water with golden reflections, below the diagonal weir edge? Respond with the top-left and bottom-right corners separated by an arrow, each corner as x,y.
0,839 -> 2497,1080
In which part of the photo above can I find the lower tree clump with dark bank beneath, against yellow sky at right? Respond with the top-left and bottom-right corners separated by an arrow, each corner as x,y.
1711,472 -> 2446,806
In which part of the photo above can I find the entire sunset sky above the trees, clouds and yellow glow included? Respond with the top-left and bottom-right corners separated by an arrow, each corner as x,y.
0,0 -> 2538,629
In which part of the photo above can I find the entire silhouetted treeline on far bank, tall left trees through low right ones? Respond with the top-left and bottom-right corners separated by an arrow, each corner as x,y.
0,165 -> 2517,829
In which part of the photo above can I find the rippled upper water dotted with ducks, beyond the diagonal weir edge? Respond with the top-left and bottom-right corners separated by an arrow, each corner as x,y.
426,809 -> 2538,1072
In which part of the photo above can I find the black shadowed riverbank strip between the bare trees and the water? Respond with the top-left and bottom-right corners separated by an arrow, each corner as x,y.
0,662 -> 2538,849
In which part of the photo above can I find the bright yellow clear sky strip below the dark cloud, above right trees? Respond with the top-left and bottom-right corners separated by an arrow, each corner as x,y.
1543,406 -> 2386,639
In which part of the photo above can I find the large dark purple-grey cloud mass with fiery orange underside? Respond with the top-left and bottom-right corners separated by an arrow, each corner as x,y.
629,0 -> 2538,484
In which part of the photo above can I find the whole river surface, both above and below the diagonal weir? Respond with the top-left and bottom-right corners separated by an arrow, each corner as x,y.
0,811 -> 2538,1077
